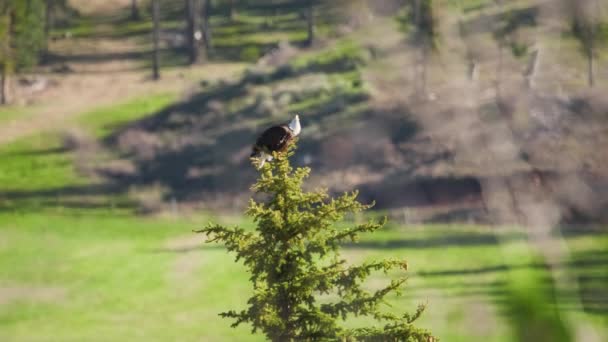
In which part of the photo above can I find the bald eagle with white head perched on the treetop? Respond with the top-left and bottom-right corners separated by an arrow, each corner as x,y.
250,115 -> 302,169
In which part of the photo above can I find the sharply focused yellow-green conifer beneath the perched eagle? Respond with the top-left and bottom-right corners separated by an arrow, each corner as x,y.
199,145 -> 434,342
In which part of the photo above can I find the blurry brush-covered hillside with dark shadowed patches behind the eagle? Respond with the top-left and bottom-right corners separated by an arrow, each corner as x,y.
85,2 -> 608,227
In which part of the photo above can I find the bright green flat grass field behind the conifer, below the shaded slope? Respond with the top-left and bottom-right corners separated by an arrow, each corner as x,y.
0,213 -> 608,341
